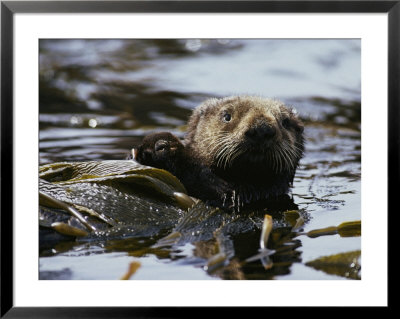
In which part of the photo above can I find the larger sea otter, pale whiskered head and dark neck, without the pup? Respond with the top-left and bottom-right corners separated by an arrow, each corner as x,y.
184,96 -> 304,208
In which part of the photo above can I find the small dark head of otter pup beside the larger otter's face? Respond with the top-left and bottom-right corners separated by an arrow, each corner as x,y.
135,132 -> 184,169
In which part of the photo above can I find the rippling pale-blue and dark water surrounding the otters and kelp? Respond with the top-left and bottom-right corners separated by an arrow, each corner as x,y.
39,39 -> 361,279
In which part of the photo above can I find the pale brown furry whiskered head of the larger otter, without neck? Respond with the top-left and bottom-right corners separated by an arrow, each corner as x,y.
186,96 -> 304,179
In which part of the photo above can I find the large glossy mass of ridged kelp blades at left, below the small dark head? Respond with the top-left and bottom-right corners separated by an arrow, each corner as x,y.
39,161 -> 194,241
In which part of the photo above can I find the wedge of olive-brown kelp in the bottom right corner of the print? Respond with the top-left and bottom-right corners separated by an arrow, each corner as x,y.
306,250 -> 361,279
